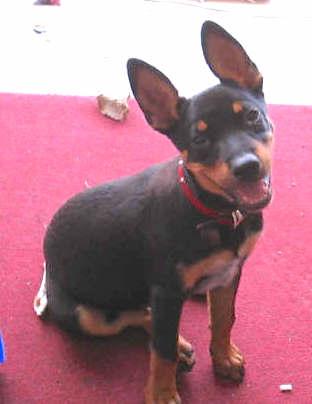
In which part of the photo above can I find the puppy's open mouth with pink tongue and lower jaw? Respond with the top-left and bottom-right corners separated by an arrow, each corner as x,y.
205,175 -> 272,213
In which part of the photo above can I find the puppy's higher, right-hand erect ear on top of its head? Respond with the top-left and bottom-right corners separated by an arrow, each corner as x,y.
201,21 -> 263,91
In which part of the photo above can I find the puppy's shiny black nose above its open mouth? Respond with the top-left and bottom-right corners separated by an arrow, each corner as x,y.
232,153 -> 261,182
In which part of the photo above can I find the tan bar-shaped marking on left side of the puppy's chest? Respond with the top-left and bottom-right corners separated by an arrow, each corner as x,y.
182,250 -> 234,289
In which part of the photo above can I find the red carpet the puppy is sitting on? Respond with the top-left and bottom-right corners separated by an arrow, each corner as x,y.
0,94 -> 312,404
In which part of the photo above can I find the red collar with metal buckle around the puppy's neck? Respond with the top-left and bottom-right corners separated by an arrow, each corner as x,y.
178,160 -> 245,229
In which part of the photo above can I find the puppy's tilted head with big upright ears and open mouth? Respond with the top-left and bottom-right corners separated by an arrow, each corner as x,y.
128,21 -> 273,212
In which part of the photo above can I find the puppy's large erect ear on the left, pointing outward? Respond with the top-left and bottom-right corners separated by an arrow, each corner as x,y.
127,59 -> 179,133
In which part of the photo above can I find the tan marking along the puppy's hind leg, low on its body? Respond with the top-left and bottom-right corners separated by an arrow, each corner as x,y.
76,305 -> 150,336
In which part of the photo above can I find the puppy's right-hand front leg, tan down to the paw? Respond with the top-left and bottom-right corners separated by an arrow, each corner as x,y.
208,273 -> 244,382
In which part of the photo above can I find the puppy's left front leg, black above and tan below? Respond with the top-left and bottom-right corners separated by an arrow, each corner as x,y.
145,286 -> 183,404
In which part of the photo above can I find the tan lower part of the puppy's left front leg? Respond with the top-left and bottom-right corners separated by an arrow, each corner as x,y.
145,349 -> 180,404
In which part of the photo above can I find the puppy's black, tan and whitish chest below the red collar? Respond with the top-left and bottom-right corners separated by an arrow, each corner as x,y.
177,221 -> 260,294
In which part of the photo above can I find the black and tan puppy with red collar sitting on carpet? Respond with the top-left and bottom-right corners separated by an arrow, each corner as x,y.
35,22 -> 273,404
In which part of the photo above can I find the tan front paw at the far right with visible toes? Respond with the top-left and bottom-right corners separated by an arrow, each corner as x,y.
210,344 -> 245,382
